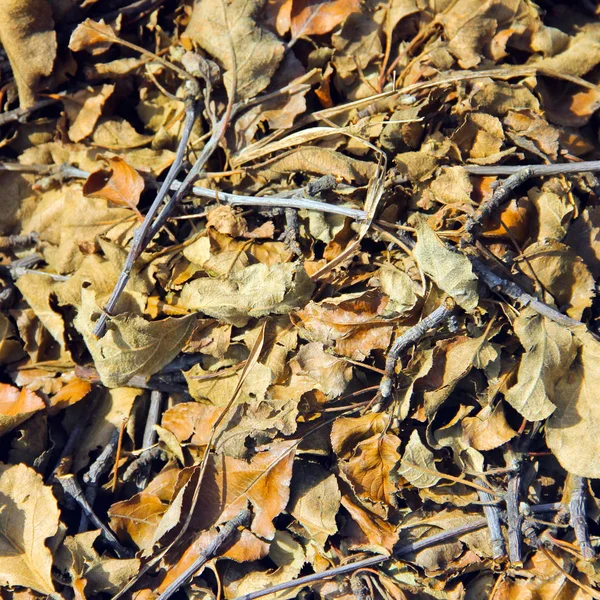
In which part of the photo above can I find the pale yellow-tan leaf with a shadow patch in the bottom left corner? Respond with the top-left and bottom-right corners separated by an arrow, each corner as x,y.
0,465 -> 60,595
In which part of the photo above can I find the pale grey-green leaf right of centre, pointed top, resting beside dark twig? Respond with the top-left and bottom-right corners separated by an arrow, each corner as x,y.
413,218 -> 479,311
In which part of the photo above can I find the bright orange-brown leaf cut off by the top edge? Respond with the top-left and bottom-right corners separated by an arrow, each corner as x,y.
291,0 -> 360,38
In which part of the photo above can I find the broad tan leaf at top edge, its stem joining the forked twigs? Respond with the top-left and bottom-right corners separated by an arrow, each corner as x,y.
184,0 -> 284,100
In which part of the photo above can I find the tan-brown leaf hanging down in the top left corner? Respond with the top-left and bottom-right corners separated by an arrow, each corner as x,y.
0,0 -> 57,108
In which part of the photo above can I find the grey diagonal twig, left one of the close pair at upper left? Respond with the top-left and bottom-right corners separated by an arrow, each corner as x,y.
94,101 -> 196,337
